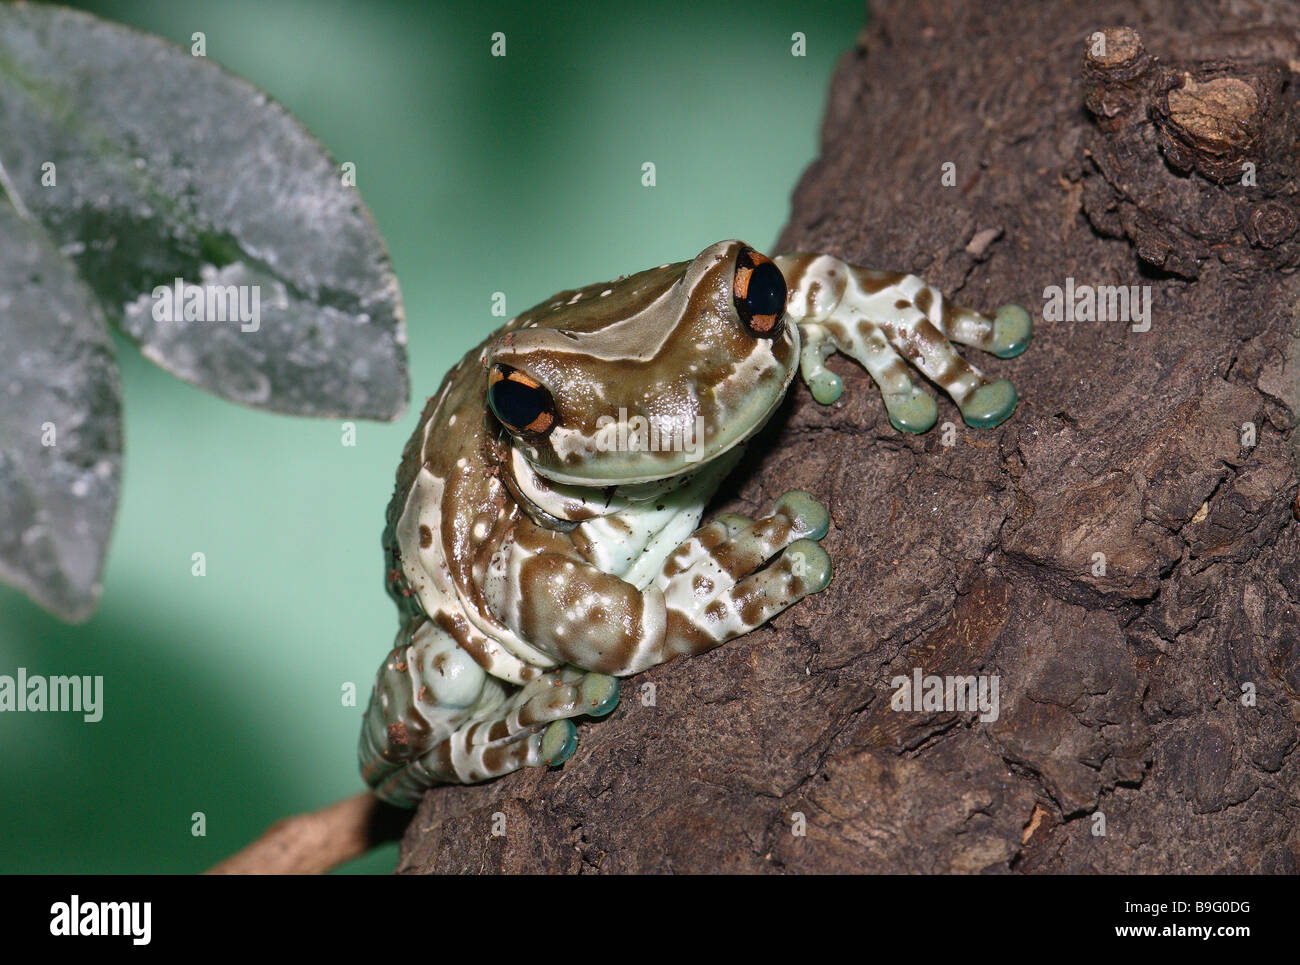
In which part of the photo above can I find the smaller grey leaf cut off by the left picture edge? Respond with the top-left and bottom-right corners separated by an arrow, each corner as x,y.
0,200 -> 122,620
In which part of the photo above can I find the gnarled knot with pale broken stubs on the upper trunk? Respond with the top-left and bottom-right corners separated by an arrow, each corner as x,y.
1083,27 -> 1300,278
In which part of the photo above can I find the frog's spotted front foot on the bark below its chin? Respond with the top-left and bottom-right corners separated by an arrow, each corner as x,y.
657,490 -> 831,658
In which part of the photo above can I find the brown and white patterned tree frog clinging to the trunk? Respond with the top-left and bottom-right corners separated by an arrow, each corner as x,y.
359,239 -> 1032,808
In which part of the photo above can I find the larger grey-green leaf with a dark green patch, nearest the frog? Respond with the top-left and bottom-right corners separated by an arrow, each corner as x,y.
0,4 -> 408,419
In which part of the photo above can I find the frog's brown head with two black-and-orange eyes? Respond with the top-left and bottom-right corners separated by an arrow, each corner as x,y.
484,241 -> 800,486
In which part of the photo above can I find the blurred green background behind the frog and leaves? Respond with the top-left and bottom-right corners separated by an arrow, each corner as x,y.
0,0 -> 865,873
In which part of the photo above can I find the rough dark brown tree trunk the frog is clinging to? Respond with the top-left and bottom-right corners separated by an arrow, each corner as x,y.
399,0 -> 1300,873
